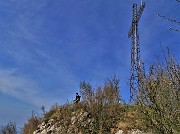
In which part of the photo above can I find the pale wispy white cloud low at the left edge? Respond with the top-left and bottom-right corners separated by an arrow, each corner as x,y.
0,69 -> 45,106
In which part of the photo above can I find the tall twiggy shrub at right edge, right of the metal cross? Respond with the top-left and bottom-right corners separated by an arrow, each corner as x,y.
137,53 -> 180,134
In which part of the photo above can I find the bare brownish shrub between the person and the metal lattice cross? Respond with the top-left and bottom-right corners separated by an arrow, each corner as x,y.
80,77 -> 121,134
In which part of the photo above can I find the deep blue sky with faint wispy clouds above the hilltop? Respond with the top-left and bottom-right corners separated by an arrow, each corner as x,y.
0,0 -> 180,127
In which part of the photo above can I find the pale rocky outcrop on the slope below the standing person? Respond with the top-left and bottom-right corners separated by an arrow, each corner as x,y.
33,110 -> 94,134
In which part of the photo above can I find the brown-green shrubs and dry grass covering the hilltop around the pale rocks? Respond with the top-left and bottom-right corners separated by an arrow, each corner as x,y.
23,52 -> 180,134
